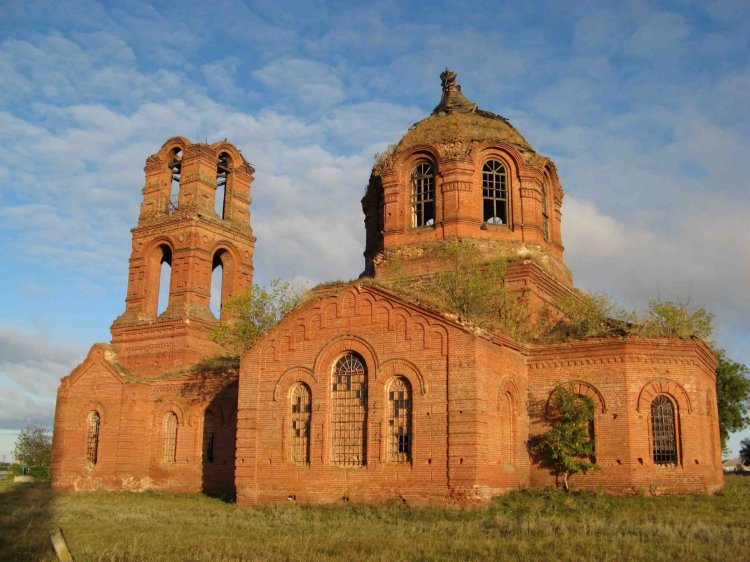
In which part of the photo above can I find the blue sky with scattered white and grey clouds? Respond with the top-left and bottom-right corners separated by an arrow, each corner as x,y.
0,0 -> 750,458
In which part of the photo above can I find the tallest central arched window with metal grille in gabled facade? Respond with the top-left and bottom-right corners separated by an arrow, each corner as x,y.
331,352 -> 367,466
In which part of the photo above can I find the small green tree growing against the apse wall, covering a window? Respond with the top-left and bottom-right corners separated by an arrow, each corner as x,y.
529,385 -> 598,492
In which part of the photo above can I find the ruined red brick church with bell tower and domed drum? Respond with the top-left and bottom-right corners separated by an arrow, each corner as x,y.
52,71 -> 723,503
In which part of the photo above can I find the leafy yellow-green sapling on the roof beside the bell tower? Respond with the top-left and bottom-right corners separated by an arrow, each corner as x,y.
209,279 -> 307,355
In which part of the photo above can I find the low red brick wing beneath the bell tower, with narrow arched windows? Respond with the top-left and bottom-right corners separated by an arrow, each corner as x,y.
52,345 -> 237,496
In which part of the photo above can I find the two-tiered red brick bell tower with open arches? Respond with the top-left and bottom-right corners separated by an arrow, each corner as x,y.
111,137 -> 255,377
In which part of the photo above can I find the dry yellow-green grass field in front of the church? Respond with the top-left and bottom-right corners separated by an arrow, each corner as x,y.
0,475 -> 750,561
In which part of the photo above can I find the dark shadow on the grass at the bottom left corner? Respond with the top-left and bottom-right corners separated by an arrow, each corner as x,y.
0,476 -> 55,560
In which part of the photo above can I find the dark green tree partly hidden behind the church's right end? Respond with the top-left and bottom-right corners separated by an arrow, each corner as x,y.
716,349 -> 750,449
